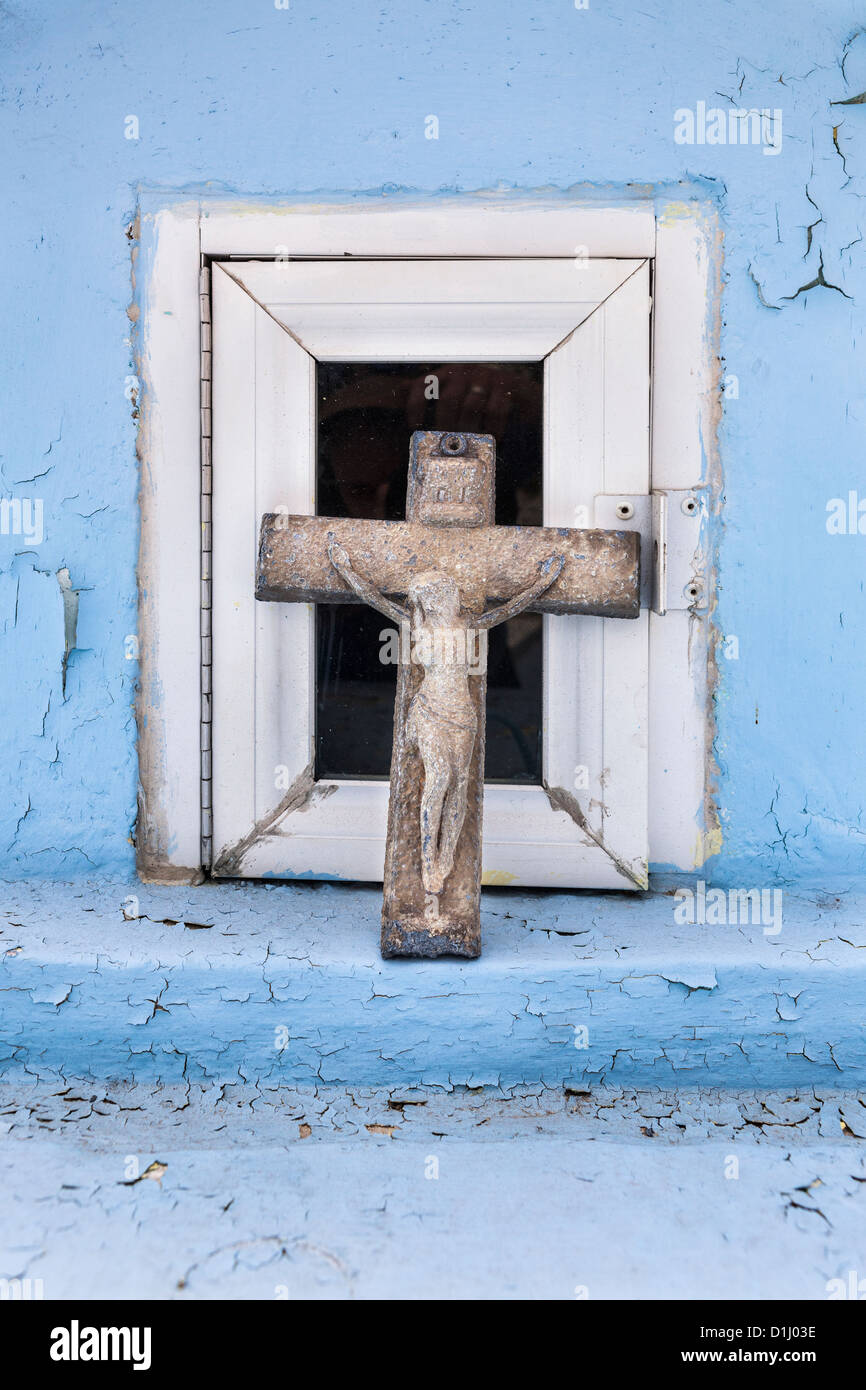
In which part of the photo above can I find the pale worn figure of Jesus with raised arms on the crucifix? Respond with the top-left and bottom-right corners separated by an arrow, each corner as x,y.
328,541 -> 564,916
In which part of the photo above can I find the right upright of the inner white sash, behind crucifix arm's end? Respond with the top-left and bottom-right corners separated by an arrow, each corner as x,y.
545,263 -> 649,887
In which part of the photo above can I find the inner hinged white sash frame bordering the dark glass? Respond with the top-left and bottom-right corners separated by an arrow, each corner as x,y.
213,260 -> 649,888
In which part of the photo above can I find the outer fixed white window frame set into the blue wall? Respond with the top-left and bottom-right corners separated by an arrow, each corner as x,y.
139,197 -> 716,887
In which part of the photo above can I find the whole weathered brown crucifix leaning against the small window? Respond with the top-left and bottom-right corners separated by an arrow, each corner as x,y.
256,431 -> 639,958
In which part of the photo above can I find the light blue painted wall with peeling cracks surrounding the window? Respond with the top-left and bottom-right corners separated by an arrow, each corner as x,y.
0,0 -> 866,888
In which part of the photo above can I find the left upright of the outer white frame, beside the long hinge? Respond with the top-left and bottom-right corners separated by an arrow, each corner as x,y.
136,204 -> 202,880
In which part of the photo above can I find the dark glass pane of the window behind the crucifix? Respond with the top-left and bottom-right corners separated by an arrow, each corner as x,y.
316,361 -> 544,783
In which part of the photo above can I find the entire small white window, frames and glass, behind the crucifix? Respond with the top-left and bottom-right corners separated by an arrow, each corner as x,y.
142,195 -> 708,888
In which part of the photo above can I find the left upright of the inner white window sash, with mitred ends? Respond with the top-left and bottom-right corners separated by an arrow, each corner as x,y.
211,264 -> 316,862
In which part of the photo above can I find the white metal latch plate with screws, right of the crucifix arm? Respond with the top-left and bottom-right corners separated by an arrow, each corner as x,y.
595,488 -> 706,613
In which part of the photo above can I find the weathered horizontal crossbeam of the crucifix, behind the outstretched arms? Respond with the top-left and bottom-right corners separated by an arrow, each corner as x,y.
256,513 -> 639,617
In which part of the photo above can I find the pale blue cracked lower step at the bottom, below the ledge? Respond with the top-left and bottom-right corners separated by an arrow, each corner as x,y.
0,1081 -> 866,1300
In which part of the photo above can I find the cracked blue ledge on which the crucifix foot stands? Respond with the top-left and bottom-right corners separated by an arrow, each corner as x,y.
0,881 -> 866,1088
